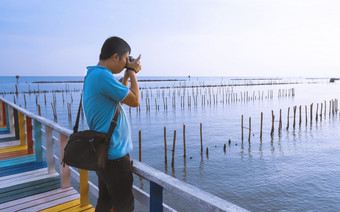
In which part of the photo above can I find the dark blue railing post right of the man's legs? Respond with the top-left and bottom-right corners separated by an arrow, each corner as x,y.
150,181 -> 163,212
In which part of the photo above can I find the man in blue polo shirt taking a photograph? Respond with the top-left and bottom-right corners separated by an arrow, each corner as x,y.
83,37 -> 141,212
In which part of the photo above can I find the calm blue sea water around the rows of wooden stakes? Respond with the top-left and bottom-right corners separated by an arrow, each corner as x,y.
0,77 -> 340,211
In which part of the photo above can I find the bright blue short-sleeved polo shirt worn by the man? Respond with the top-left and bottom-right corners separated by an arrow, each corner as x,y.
83,66 -> 132,160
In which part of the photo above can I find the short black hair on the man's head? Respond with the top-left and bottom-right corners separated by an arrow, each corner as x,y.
99,37 -> 131,60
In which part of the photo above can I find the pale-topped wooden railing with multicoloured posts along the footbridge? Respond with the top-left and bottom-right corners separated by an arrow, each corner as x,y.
0,97 -> 247,211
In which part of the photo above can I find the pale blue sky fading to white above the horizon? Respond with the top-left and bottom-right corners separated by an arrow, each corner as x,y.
0,0 -> 340,77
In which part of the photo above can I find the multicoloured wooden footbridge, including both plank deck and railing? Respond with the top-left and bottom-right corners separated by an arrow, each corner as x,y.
0,97 -> 247,212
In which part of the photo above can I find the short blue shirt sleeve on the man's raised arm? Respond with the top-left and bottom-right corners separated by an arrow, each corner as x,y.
98,73 -> 130,102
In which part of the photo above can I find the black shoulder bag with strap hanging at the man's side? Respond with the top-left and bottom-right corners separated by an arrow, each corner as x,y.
63,96 -> 119,171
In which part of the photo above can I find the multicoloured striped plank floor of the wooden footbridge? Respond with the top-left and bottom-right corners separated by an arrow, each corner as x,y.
0,120 -> 95,212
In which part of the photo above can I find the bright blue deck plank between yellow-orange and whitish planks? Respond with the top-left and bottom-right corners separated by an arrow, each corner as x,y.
0,162 -> 47,177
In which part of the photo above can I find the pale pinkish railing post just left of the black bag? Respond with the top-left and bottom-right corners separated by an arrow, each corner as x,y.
59,133 -> 71,188
